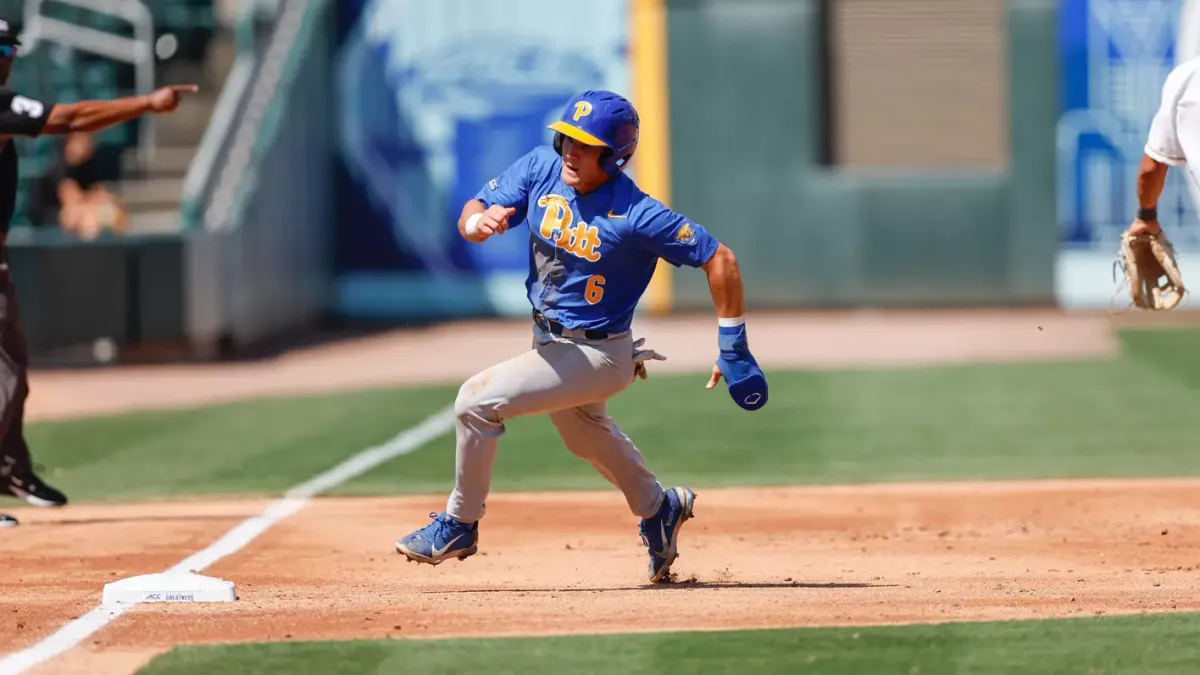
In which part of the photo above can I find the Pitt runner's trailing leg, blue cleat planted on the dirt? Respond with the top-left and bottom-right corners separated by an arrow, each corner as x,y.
550,404 -> 696,583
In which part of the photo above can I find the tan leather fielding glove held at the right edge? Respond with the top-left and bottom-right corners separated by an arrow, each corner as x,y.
1114,225 -> 1187,310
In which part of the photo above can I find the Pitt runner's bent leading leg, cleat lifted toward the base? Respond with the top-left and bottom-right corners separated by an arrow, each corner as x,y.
396,330 -> 632,563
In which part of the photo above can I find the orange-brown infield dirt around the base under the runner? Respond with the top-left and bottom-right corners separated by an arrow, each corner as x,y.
7,480 -> 1200,674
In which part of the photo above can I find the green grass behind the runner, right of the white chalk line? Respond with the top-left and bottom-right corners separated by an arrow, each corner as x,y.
340,348 -> 1200,492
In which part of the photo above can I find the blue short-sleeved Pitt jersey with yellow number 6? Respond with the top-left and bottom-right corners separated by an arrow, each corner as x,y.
475,147 -> 718,333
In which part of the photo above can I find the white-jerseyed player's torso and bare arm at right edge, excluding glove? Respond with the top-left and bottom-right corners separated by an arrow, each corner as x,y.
1126,58 -> 1200,235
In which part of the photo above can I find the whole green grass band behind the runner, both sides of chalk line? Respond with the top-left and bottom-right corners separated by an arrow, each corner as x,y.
18,330 -> 1200,500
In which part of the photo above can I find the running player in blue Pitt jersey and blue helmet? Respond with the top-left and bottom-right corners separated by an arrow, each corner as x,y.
396,91 -> 767,583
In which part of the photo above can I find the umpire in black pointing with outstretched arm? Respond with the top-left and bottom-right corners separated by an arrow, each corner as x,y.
0,19 -> 197,527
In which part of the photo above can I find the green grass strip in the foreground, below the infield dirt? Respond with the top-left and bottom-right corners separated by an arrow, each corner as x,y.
140,614 -> 1200,675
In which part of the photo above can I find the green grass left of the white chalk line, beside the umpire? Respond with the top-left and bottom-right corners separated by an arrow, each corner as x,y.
28,388 -> 456,501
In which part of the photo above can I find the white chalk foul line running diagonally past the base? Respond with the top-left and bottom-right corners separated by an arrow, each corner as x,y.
0,407 -> 454,675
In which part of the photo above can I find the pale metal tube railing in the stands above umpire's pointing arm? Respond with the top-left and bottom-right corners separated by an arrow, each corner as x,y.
20,0 -> 156,166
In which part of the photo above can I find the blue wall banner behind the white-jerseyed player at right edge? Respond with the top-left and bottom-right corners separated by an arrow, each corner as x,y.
1057,0 -> 1200,249
